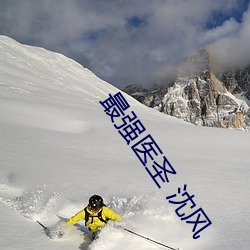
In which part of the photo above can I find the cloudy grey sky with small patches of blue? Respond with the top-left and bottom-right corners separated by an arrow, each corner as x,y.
0,0 -> 250,88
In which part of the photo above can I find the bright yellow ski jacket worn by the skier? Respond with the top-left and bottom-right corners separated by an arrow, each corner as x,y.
67,206 -> 122,233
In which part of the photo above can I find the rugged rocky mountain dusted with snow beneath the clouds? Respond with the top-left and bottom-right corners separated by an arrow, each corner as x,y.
124,49 -> 250,130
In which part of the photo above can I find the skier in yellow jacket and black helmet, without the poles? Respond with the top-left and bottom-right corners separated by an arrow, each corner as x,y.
67,194 -> 122,239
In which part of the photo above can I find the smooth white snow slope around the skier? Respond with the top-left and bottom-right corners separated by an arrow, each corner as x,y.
0,36 -> 250,250
